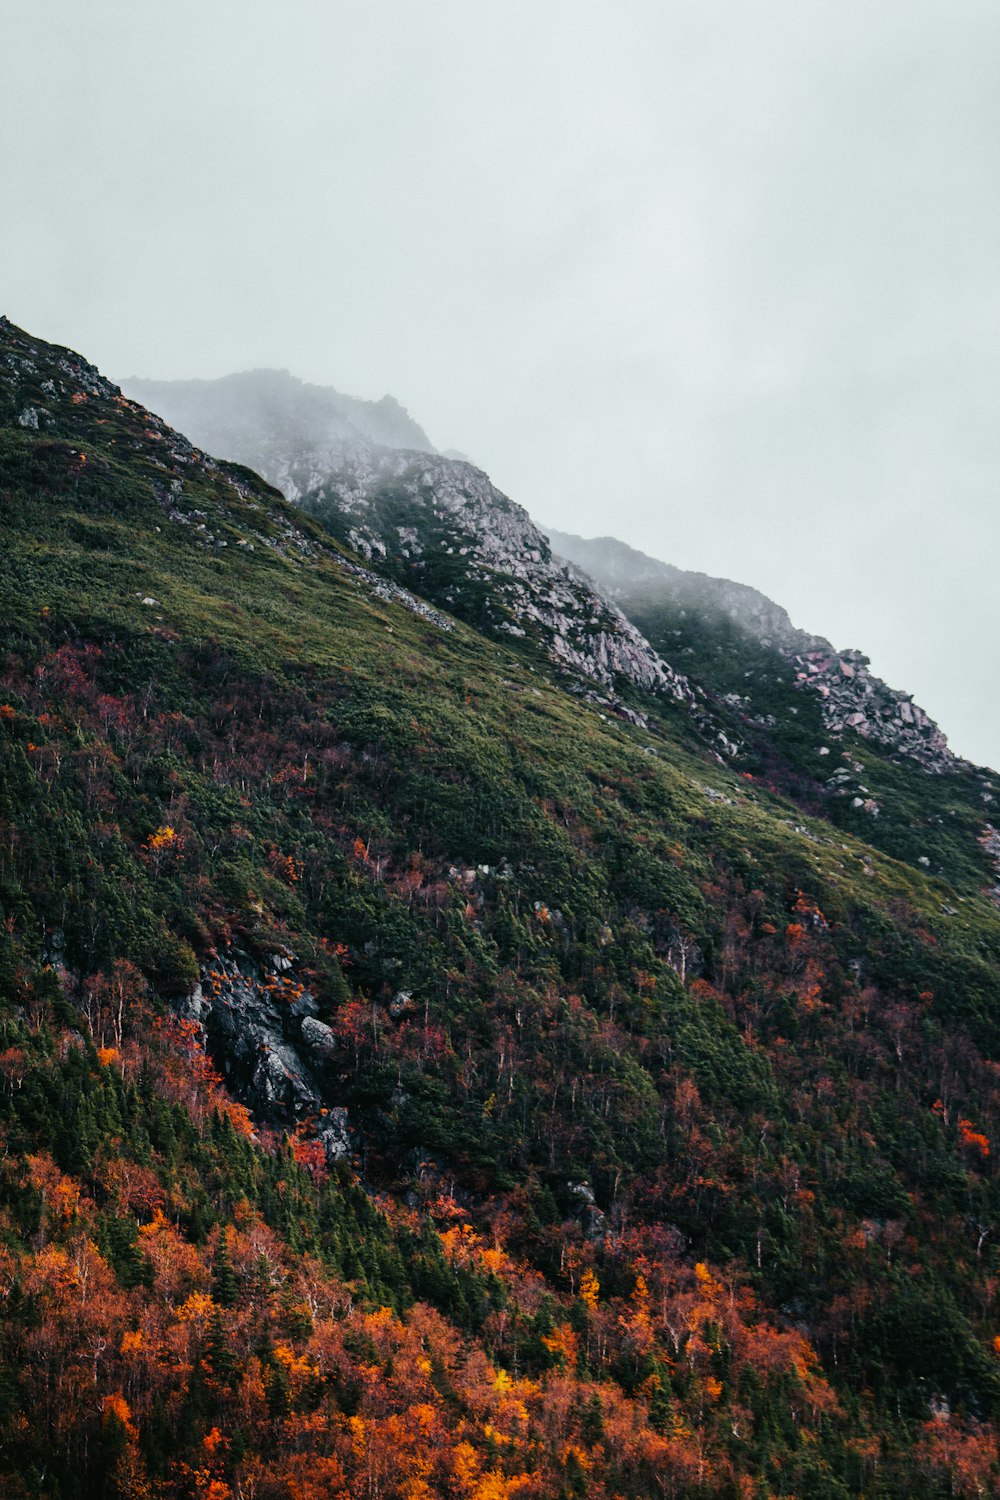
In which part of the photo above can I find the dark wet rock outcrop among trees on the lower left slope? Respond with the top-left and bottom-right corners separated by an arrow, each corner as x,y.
180,948 -> 351,1163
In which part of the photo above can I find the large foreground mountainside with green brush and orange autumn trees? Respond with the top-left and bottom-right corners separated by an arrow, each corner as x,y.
0,320 -> 1000,1500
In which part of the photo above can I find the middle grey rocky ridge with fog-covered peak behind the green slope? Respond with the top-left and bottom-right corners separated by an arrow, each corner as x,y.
126,371 -> 694,704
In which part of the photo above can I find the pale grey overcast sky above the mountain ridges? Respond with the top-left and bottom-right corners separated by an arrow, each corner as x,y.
7,0 -> 1000,767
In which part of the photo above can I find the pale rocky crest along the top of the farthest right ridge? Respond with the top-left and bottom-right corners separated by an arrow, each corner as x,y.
549,530 -> 960,773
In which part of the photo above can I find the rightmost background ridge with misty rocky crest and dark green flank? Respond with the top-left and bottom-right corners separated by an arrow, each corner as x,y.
549,531 -> 1000,890
